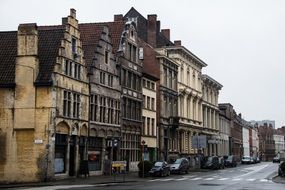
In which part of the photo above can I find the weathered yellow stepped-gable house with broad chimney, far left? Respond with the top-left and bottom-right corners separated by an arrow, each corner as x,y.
0,9 -> 89,182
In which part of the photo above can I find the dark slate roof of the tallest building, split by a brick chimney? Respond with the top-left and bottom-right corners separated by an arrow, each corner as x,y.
124,7 -> 174,47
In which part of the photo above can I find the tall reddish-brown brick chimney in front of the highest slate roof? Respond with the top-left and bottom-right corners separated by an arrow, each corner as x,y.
147,14 -> 157,48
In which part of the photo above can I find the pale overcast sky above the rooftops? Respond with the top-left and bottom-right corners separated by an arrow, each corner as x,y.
0,0 -> 285,127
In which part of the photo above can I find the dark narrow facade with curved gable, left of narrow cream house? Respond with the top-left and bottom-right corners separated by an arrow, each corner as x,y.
118,21 -> 142,170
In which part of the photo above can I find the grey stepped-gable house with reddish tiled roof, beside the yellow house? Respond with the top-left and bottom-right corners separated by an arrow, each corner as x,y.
79,23 -> 121,174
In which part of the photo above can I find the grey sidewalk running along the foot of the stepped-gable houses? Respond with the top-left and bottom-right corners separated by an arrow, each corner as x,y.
0,172 -> 146,189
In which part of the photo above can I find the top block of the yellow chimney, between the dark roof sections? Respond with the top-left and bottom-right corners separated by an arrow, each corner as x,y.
18,23 -> 38,56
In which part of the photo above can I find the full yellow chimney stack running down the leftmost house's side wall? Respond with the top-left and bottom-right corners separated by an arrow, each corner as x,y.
14,23 -> 39,129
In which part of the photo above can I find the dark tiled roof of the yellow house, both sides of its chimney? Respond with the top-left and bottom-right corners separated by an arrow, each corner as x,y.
0,26 -> 65,87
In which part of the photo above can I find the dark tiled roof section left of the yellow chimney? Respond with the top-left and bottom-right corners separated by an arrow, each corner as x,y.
0,31 -> 17,87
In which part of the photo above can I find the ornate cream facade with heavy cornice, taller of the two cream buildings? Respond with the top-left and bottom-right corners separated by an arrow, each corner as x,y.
162,41 -> 206,157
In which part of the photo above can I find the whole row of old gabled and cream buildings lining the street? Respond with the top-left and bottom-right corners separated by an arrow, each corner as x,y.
0,8 -> 280,182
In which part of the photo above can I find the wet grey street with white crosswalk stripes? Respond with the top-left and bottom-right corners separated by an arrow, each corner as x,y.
19,162 -> 285,190
